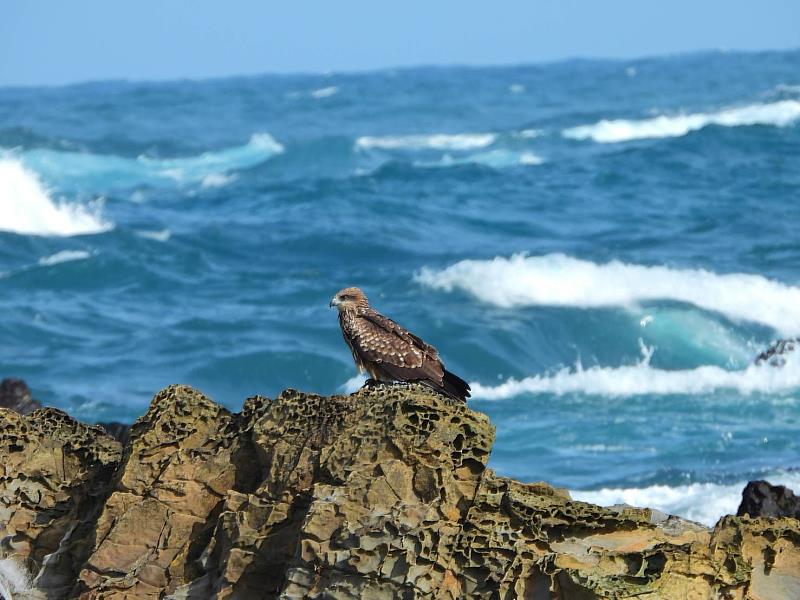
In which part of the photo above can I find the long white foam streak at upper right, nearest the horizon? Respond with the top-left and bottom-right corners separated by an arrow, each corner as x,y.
562,100 -> 800,144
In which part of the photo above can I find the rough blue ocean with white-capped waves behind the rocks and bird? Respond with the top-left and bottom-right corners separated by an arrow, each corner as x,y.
0,51 -> 800,523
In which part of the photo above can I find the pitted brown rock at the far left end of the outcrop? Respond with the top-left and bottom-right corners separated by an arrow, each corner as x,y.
0,408 -> 121,598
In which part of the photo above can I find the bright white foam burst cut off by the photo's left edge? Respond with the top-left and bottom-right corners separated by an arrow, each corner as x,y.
0,158 -> 113,236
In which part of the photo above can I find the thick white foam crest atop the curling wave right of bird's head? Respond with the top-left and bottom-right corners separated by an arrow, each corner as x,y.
415,254 -> 800,335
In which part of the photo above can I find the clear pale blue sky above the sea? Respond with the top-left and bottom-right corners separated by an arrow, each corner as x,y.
0,0 -> 800,85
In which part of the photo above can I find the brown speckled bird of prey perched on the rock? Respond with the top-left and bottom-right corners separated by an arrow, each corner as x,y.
330,287 -> 469,402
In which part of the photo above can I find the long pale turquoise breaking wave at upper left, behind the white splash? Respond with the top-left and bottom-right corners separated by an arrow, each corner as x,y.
14,133 -> 284,189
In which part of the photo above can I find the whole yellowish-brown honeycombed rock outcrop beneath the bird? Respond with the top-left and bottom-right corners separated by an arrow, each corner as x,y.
0,386 -> 800,600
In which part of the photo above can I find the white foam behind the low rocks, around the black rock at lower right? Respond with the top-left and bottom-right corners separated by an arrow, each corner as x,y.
570,472 -> 800,526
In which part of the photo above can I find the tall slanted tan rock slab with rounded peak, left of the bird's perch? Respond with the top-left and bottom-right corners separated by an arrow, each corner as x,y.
77,386 -> 254,598
